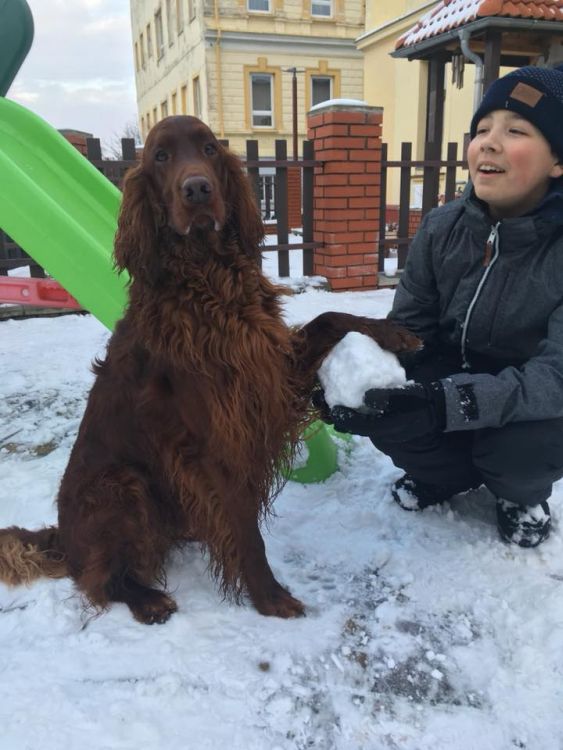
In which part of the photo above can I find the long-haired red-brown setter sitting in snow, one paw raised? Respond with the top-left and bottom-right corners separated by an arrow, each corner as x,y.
0,117 -> 418,623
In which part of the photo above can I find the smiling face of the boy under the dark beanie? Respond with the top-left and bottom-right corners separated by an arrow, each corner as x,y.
467,109 -> 563,219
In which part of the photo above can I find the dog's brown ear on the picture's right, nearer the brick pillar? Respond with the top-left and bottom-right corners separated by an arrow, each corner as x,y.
221,146 -> 264,260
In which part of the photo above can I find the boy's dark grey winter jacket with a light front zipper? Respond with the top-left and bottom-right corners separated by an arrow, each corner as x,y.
390,180 -> 563,431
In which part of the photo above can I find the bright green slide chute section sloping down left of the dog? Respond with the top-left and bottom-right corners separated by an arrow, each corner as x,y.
0,97 -> 128,330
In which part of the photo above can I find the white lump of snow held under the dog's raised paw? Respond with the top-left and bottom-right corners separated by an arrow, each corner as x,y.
318,332 -> 406,409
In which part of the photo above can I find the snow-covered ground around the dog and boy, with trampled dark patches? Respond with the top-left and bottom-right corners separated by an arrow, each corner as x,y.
0,278 -> 563,750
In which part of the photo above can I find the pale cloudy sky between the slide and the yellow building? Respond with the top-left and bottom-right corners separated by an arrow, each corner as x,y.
8,0 -> 137,153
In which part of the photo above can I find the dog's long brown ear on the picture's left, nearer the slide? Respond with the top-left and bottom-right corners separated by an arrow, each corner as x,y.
113,164 -> 165,283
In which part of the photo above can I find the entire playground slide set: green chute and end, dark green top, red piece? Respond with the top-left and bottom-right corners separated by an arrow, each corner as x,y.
0,0 -> 338,483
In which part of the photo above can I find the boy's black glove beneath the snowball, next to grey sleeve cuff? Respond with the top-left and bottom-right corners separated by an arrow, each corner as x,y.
329,381 -> 446,443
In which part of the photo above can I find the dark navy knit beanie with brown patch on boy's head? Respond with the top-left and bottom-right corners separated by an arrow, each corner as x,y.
471,65 -> 563,159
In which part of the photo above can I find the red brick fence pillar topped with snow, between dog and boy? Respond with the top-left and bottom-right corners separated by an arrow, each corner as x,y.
307,100 -> 383,291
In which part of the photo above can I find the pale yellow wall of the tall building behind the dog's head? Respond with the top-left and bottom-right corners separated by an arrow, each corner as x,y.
131,0 -> 365,156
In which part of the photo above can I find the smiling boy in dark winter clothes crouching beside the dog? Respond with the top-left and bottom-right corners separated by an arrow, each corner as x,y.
320,66 -> 563,547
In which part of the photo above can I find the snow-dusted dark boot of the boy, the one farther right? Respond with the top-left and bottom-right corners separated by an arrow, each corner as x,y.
497,497 -> 551,547
